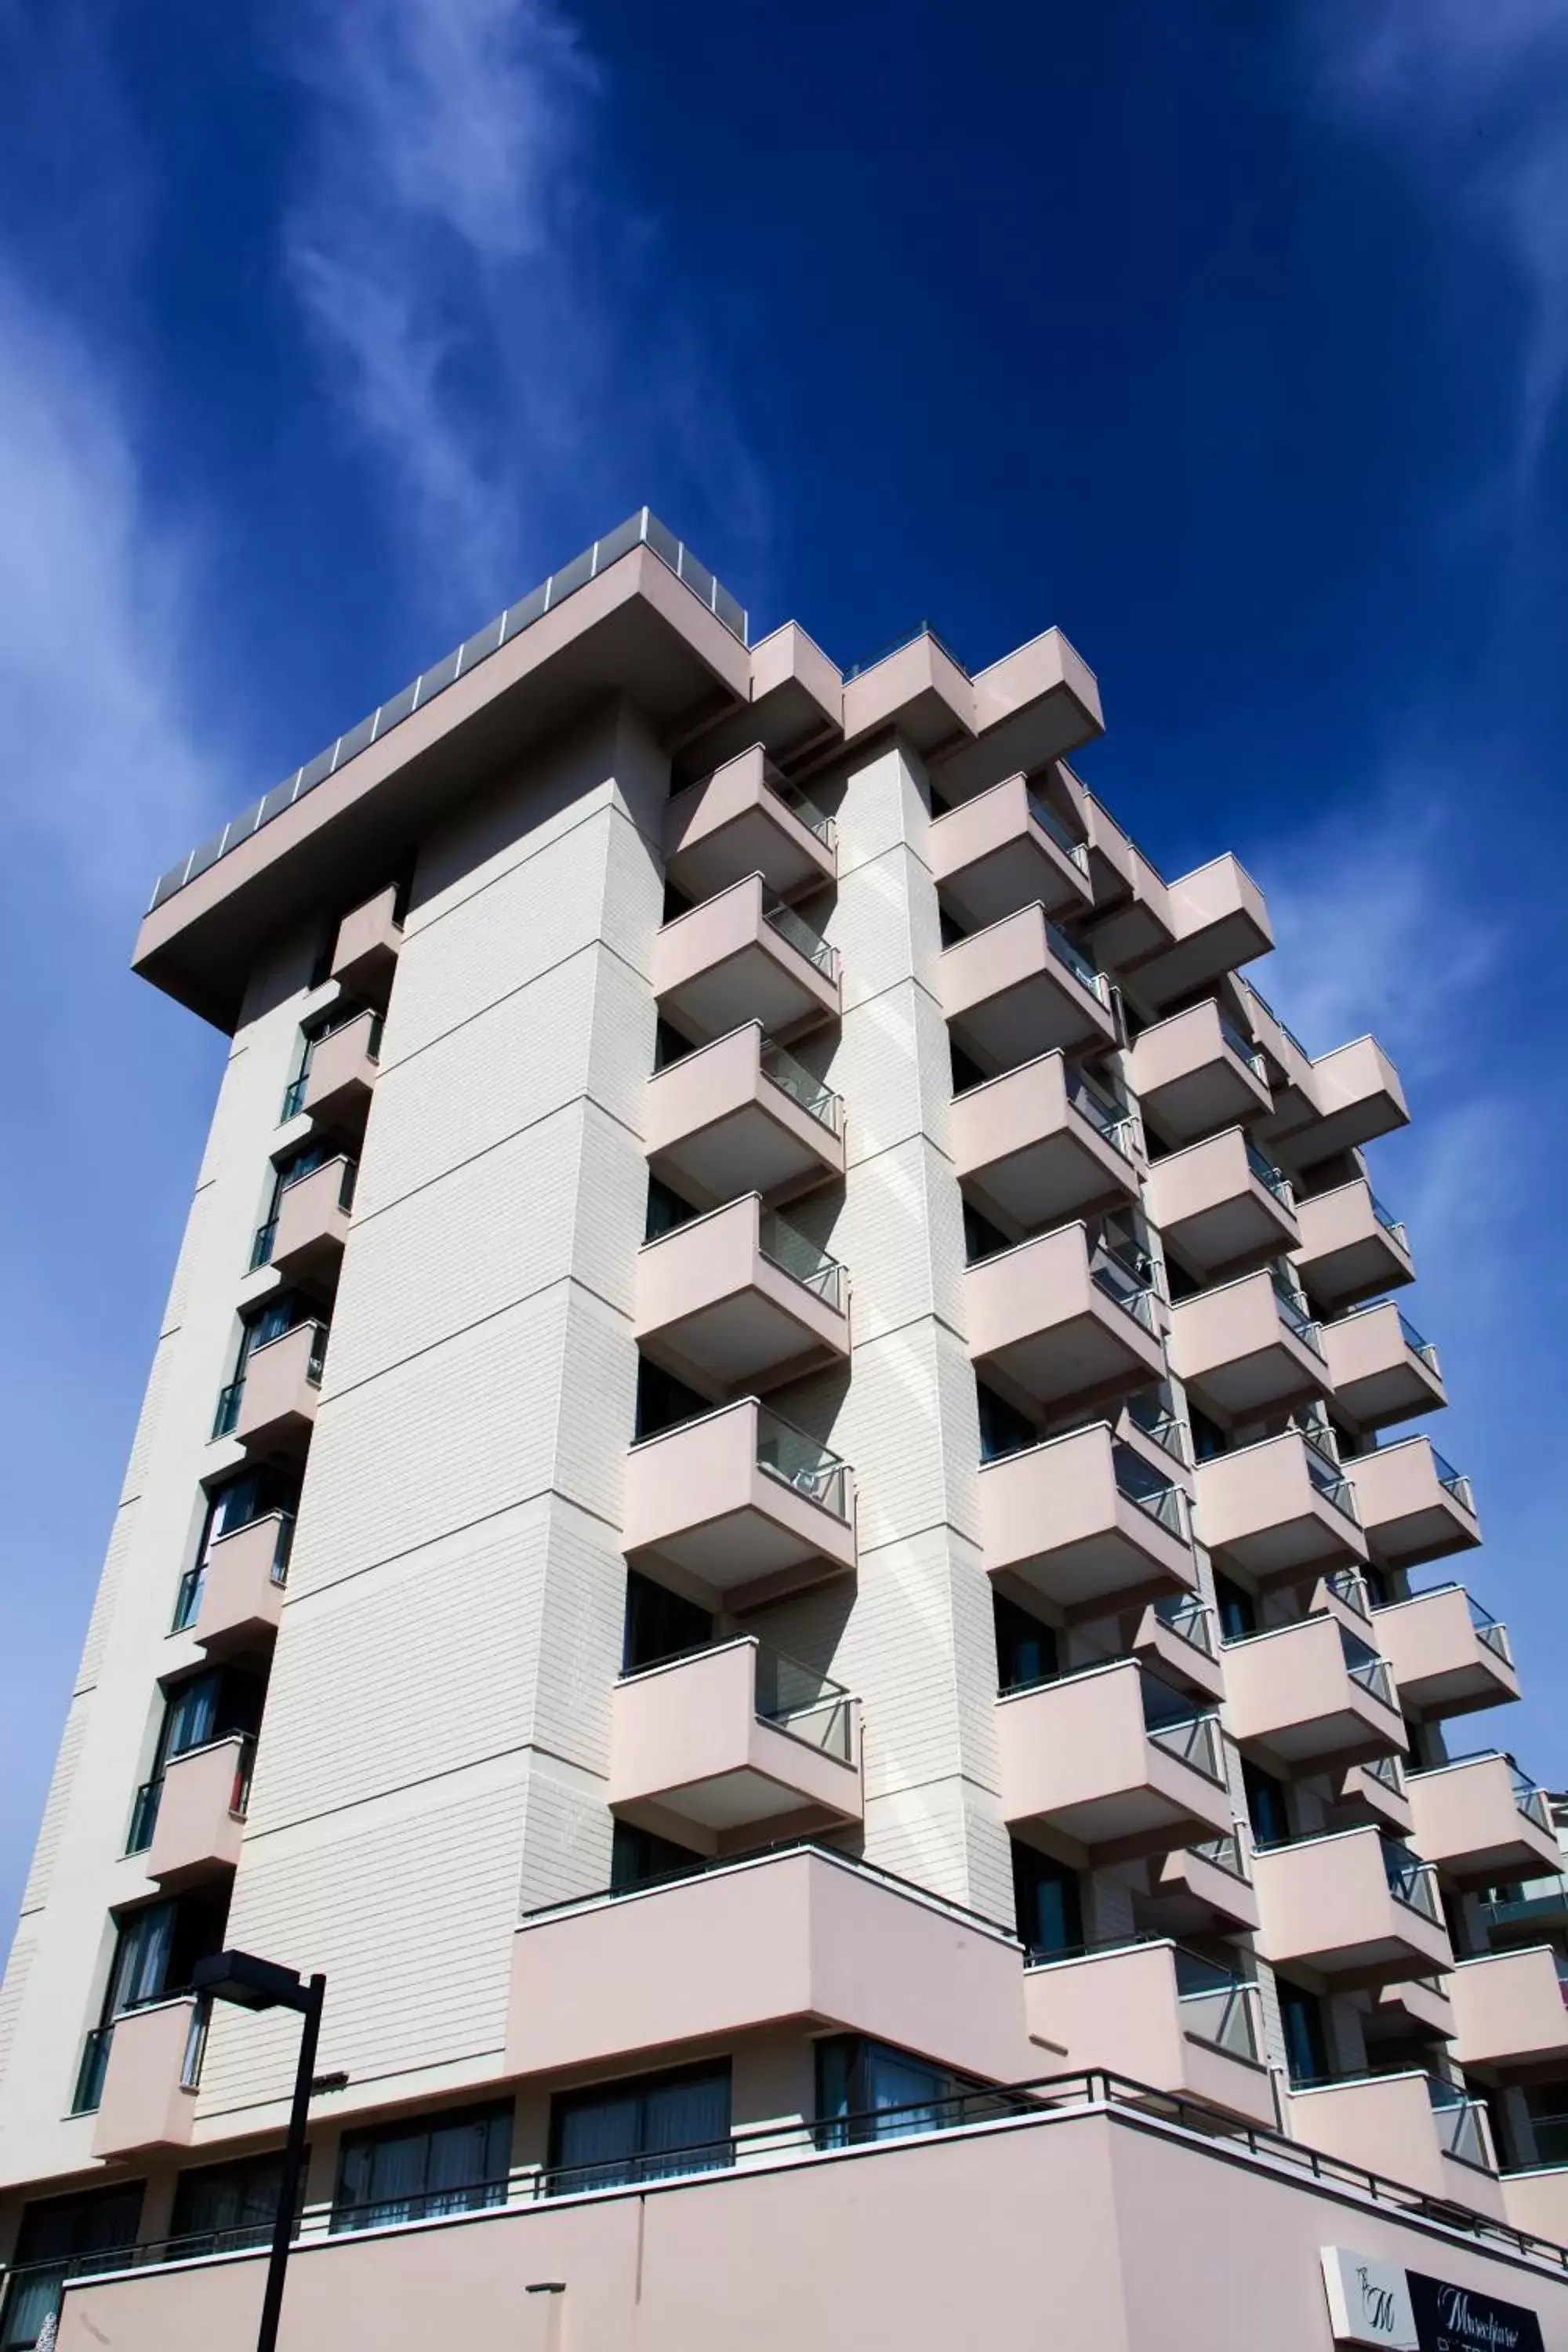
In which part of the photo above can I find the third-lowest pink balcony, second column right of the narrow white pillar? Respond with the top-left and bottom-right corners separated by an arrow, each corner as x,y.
1222,1616 -> 1406,1773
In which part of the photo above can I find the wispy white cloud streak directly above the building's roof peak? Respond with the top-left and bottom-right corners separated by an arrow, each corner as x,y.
287,0 -> 764,619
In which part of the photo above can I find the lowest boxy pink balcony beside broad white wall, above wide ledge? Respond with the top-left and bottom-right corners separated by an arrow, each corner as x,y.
609,1635 -> 860,1842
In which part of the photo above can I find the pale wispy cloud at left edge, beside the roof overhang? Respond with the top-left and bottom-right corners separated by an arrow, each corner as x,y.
0,270 -> 212,898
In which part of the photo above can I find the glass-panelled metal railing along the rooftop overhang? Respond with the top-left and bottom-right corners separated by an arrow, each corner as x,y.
148,506 -> 748,913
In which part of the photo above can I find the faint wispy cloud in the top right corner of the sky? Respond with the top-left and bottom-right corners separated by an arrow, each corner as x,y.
1302,0 -> 1568,477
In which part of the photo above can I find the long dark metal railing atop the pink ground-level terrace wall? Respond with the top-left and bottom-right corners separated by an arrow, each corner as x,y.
27,2067 -> 1568,2288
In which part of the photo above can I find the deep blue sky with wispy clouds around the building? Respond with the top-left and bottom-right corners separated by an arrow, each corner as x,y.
0,0 -> 1568,1912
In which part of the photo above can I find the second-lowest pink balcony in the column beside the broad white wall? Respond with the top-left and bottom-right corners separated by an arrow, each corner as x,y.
621,1397 -> 855,1606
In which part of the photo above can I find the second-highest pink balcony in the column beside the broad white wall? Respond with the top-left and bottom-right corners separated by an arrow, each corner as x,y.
654,875 -> 839,1044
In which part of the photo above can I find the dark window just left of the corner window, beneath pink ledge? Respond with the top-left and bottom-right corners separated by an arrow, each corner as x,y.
548,2063 -> 734,2197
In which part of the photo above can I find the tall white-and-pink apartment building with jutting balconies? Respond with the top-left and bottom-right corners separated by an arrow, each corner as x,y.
0,513 -> 1568,2352
